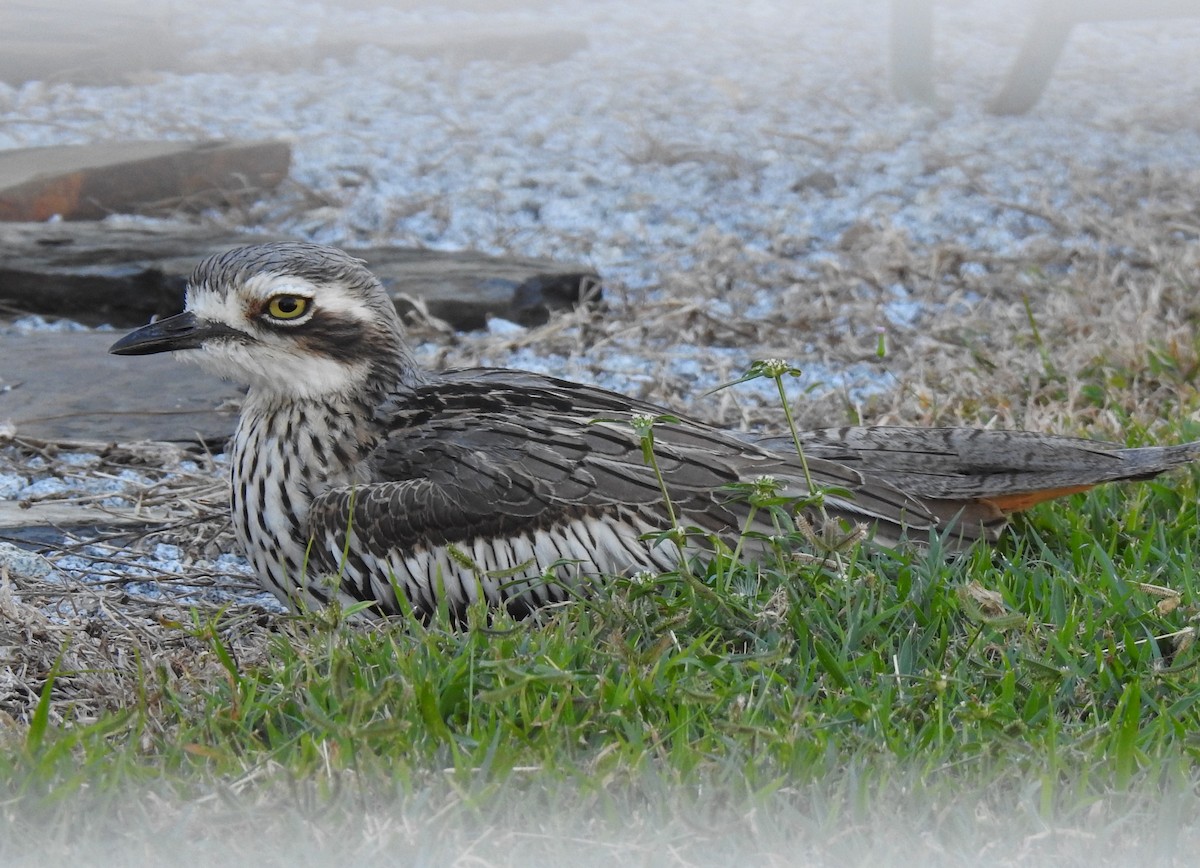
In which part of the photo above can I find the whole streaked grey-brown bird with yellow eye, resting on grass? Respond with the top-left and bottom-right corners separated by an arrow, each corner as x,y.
110,241 -> 1200,618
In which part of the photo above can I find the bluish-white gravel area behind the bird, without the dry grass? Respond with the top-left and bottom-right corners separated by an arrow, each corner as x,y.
0,0 -> 1200,397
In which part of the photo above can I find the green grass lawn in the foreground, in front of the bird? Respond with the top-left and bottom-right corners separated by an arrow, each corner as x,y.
7,388 -> 1200,864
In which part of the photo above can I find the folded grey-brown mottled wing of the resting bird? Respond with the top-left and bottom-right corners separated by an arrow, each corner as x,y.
310,370 -> 943,593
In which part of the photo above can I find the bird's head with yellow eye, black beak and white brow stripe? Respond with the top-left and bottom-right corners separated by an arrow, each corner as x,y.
109,241 -> 419,400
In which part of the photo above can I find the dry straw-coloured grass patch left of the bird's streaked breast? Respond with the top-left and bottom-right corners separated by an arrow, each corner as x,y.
0,438 -> 268,725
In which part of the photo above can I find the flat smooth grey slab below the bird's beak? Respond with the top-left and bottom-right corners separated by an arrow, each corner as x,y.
0,330 -> 241,447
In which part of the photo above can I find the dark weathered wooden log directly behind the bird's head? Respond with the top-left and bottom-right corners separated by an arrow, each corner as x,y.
0,221 -> 600,329
